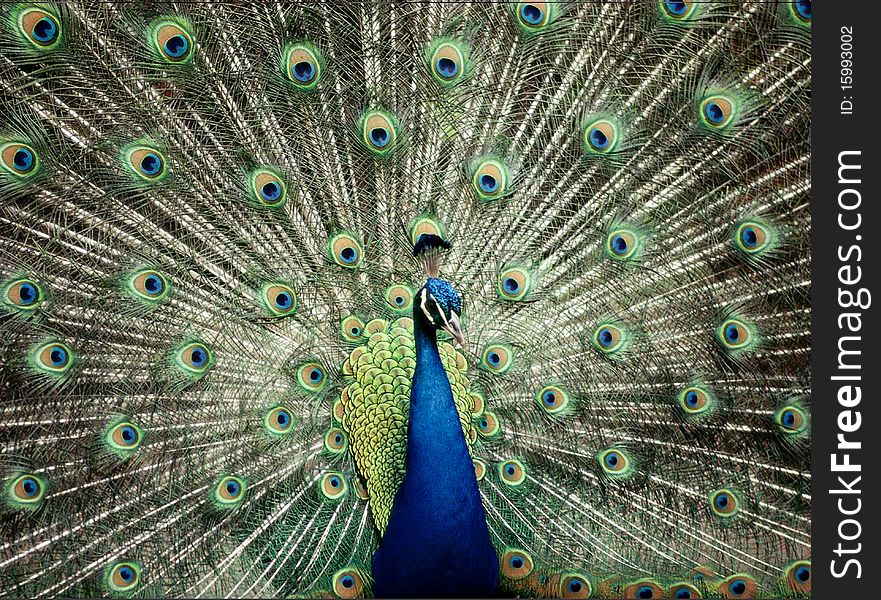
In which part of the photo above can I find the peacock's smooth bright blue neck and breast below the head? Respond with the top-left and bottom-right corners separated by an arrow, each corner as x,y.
373,313 -> 499,597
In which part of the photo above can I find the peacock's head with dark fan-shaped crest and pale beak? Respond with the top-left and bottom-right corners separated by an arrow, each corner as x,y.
413,233 -> 468,348
